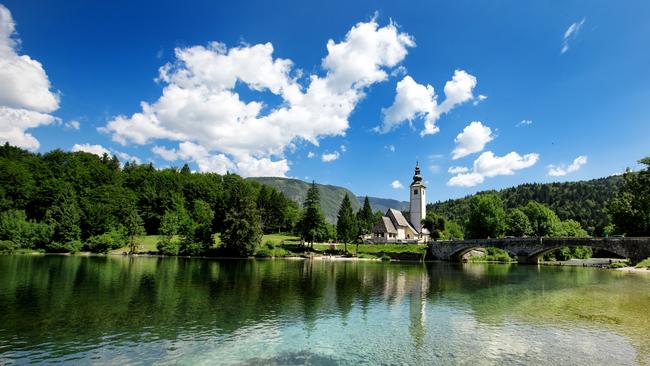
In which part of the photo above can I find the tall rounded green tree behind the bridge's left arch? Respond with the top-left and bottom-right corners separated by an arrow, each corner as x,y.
465,194 -> 506,239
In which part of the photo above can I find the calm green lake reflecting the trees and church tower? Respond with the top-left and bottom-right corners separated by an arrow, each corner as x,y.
0,255 -> 650,365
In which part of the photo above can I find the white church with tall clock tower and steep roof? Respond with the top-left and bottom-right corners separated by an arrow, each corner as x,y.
372,163 -> 429,243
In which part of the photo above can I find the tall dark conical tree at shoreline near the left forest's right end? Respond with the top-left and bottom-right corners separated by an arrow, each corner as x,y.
221,182 -> 262,256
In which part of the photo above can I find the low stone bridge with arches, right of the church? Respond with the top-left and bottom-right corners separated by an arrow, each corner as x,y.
428,237 -> 650,264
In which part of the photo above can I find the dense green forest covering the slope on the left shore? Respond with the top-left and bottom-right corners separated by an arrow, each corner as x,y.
0,144 -> 300,254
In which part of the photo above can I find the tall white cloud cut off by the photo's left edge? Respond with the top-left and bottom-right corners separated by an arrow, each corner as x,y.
0,4 -> 60,150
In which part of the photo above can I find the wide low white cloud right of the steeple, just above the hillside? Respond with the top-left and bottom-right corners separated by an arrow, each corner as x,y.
447,151 -> 539,187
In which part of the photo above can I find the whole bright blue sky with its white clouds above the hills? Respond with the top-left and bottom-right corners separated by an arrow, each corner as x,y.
0,0 -> 650,201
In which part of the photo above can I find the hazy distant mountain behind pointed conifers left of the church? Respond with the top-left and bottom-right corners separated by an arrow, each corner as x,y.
248,177 -> 361,224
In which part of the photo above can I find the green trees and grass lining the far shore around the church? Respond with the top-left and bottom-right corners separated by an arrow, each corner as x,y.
0,144 -> 650,260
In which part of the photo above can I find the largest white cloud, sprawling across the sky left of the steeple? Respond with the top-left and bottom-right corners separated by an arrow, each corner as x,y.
100,19 -> 414,176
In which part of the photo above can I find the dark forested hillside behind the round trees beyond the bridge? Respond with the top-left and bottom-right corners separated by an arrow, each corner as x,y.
427,176 -> 624,233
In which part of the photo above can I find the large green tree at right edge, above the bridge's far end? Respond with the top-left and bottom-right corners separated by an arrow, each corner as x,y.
607,157 -> 650,236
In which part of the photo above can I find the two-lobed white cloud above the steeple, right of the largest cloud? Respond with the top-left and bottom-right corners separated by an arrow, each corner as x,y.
375,70 -> 478,136
